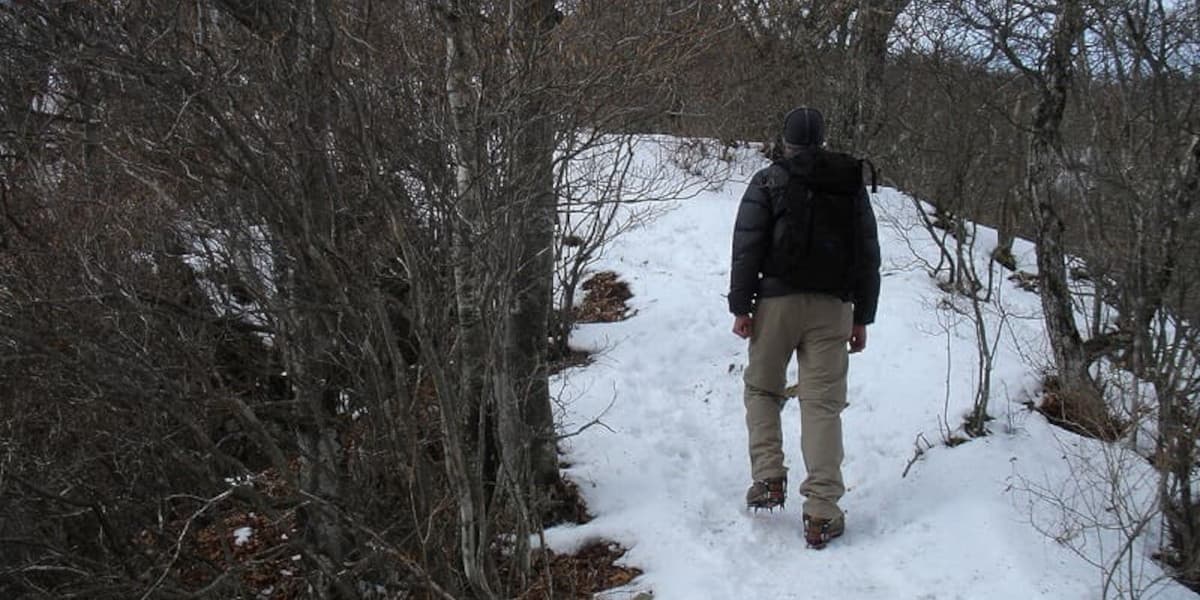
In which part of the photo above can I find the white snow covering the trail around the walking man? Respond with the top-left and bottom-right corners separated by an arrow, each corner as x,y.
547,138 -> 1195,600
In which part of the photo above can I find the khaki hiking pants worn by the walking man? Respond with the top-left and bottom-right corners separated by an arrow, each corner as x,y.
744,294 -> 853,518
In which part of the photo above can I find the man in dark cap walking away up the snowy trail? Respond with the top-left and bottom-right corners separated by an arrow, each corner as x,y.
728,107 -> 880,548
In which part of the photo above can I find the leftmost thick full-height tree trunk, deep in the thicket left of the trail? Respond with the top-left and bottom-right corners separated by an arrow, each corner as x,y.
277,0 -> 356,598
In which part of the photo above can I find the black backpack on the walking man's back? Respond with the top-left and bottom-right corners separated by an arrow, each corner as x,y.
775,150 -> 875,292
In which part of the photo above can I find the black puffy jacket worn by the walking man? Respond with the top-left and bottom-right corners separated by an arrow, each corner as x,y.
728,154 -> 880,325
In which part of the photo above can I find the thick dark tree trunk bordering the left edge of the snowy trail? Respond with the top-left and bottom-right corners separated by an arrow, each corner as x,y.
497,0 -> 558,587
